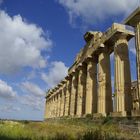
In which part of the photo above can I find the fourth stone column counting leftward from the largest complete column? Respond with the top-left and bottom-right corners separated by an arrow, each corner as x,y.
76,65 -> 87,117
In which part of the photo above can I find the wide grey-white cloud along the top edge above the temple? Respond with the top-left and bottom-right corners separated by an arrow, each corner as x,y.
57,0 -> 138,24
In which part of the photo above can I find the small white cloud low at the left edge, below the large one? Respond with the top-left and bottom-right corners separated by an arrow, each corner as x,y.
0,80 -> 17,99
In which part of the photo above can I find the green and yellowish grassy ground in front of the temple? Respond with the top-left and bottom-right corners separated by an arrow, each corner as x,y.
0,119 -> 139,140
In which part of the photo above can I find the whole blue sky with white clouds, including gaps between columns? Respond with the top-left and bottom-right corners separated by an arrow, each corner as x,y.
0,0 -> 139,120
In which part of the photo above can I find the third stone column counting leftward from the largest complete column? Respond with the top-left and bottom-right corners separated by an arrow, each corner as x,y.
85,58 -> 97,114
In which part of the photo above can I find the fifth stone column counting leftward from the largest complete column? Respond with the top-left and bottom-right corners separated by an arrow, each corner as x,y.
70,72 -> 78,116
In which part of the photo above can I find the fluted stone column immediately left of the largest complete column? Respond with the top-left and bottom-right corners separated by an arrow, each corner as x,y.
98,49 -> 113,116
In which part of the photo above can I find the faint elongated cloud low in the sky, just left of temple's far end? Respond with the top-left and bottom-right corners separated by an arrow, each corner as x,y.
22,82 -> 45,97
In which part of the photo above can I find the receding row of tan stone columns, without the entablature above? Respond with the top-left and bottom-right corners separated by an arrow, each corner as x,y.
45,31 -> 135,118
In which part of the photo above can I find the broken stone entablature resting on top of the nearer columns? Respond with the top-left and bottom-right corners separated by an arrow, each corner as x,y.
68,23 -> 134,74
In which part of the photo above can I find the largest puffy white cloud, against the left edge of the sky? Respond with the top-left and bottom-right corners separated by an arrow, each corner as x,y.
0,11 -> 52,73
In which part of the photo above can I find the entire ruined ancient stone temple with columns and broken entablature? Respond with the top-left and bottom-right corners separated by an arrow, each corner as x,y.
45,8 -> 140,119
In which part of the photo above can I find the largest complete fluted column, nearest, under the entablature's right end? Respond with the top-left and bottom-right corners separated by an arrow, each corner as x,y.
114,35 -> 132,116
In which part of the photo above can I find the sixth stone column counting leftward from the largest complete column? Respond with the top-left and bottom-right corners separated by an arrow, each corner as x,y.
64,75 -> 72,116
